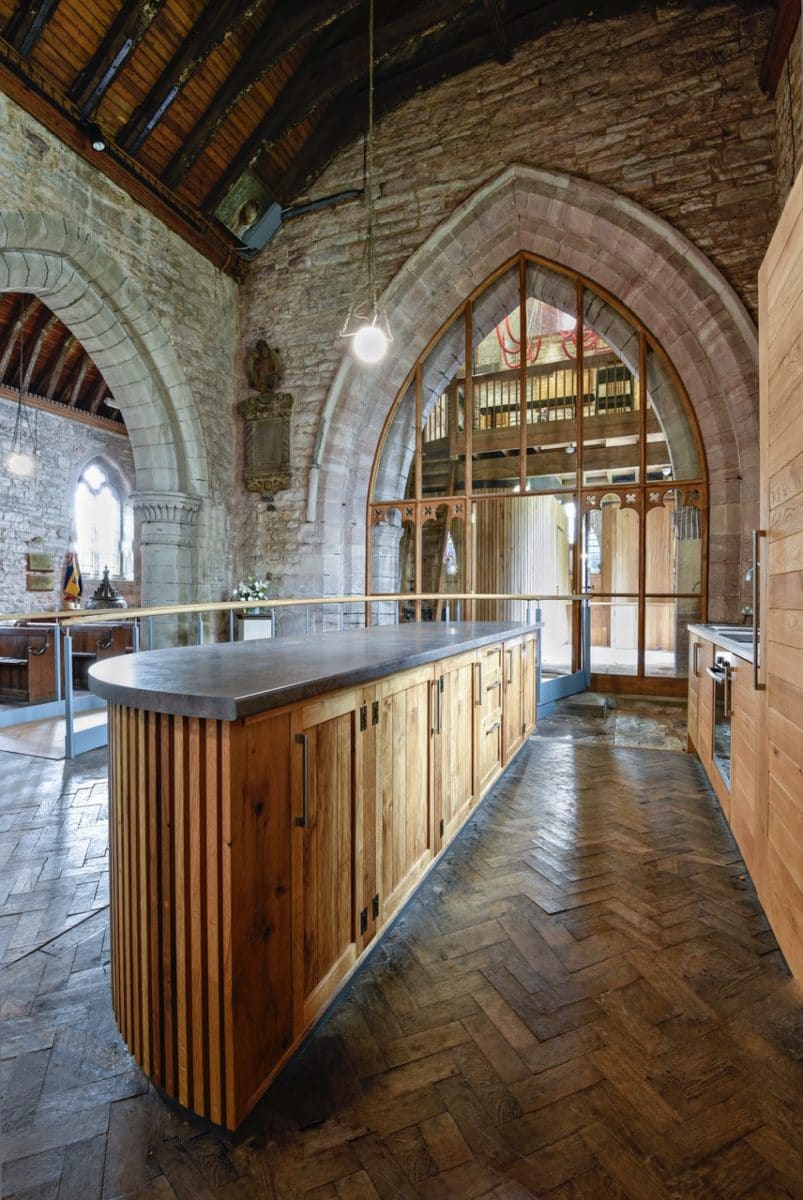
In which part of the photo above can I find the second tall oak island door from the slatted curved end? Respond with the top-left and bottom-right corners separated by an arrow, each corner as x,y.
376,666 -> 439,923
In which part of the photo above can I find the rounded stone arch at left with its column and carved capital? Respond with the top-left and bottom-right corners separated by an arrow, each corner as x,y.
0,211 -> 209,604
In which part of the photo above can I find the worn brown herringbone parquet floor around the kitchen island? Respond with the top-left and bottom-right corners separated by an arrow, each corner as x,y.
0,700 -> 803,1200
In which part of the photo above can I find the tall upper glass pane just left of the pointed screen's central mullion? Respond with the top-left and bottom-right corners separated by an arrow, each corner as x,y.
472,266 -> 521,492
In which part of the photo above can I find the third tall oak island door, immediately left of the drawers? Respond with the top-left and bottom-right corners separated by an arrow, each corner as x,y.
430,654 -> 474,853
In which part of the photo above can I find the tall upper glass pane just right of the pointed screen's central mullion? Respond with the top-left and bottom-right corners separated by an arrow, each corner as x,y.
526,263 -> 577,492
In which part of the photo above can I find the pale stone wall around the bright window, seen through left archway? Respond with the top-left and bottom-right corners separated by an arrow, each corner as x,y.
0,397 -> 138,612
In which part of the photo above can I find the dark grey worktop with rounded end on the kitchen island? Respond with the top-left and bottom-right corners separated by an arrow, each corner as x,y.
89,620 -> 540,721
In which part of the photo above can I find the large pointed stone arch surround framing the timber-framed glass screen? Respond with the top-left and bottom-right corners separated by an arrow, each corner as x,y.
307,164 -> 759,618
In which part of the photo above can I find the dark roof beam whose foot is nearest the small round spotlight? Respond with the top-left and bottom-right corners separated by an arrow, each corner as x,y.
116,0 -> 266,154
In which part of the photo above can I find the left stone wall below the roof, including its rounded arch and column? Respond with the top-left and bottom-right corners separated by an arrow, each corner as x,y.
0,96 -> 238,602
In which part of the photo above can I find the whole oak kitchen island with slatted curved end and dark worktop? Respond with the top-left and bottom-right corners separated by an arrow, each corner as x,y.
90,622 -> 538,1128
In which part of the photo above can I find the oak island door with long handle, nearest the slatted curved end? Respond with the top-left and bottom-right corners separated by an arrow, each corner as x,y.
292,691 -> 361,1036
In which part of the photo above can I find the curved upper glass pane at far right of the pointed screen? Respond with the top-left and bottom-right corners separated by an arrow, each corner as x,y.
647,349 -> 702,480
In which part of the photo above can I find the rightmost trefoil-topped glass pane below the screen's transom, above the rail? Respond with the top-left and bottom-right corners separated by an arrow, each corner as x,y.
646,487 -> 702,595
